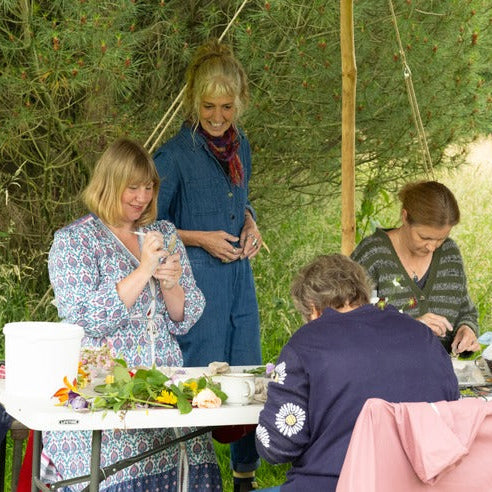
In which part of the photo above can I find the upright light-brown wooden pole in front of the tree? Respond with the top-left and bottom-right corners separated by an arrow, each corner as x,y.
340,0 -> 357,255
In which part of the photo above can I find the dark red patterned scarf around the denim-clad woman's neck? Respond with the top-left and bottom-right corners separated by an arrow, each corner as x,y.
198,125 -> 244,186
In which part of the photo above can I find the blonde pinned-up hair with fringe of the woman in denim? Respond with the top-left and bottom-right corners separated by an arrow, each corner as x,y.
183,39 -> 249,126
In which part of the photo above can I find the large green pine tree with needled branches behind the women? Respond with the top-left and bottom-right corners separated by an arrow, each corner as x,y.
0,0 -> 492,321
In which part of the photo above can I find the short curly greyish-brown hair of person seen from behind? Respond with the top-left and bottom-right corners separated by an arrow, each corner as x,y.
291,253 -> 371,321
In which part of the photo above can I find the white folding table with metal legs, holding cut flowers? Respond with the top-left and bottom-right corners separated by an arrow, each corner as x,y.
0,368 -> 263,492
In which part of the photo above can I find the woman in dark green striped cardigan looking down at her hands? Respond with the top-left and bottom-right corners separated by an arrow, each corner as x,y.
352,181 -> 480,354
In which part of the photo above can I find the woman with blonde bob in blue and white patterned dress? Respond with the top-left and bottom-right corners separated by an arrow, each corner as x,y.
47,139 -> 222,492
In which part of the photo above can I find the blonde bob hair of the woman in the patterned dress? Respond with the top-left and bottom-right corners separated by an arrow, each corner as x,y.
82,138 -> 160,226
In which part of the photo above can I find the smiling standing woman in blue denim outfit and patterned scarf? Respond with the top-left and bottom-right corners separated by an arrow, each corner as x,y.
154,40 -> 262,490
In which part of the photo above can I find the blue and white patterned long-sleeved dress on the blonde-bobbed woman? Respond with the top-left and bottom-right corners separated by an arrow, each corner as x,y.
43,215 -> 222,492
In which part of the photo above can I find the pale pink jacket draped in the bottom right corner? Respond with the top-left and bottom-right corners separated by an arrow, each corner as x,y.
337,398 -> 492,492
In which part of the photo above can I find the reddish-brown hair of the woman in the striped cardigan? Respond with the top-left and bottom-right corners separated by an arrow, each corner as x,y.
398,181 -> 460,228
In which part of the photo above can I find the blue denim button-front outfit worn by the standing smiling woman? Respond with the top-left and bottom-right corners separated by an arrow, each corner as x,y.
154,123 -> 261,472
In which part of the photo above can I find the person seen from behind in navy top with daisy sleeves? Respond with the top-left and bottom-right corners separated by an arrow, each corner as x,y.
256,254 -> 459,492
